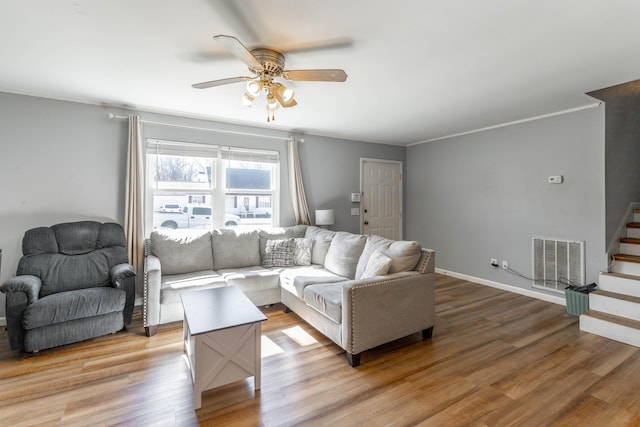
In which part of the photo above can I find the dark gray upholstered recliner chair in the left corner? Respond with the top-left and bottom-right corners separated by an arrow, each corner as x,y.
0,221 -> 135,352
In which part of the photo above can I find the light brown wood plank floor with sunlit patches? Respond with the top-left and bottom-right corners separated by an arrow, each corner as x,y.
0,276 -> 640,427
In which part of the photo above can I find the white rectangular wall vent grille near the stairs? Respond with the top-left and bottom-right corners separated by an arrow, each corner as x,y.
533,237 -> 585,292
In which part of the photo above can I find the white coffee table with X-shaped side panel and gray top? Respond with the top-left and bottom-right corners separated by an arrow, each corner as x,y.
182,286 -> 267,409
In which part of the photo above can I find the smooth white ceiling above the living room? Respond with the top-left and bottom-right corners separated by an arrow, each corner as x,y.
0,0 -> 640,145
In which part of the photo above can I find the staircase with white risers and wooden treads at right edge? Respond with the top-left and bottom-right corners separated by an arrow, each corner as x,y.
580,209 -> 640,347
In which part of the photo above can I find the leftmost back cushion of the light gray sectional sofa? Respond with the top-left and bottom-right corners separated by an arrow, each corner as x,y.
150,230 -> 213,275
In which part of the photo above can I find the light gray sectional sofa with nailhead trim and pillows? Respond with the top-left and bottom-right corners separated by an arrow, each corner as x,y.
144,225 -> 435,366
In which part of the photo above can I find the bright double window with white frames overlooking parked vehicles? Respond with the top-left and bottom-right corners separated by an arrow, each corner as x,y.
145,139 -> 279,232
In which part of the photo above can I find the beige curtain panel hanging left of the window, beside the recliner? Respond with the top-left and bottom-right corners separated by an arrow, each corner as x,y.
124,114 -> 144,289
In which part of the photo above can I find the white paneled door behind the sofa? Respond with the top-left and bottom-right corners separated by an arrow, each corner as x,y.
360,159 -> 402,240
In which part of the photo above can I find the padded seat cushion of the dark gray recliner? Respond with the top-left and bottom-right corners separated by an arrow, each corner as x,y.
22,287 -> 126,330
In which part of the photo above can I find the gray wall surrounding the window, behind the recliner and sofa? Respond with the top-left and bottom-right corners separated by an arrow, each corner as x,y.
0,92 -> 405,318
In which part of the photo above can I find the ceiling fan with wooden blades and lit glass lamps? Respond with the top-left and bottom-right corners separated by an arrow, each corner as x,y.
191,34 -> 347,122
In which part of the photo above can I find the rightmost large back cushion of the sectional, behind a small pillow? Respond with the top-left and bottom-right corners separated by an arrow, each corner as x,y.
355,235 -> 422,279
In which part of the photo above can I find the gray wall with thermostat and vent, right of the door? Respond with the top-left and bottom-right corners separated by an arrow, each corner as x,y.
406,106 -> 606,293
